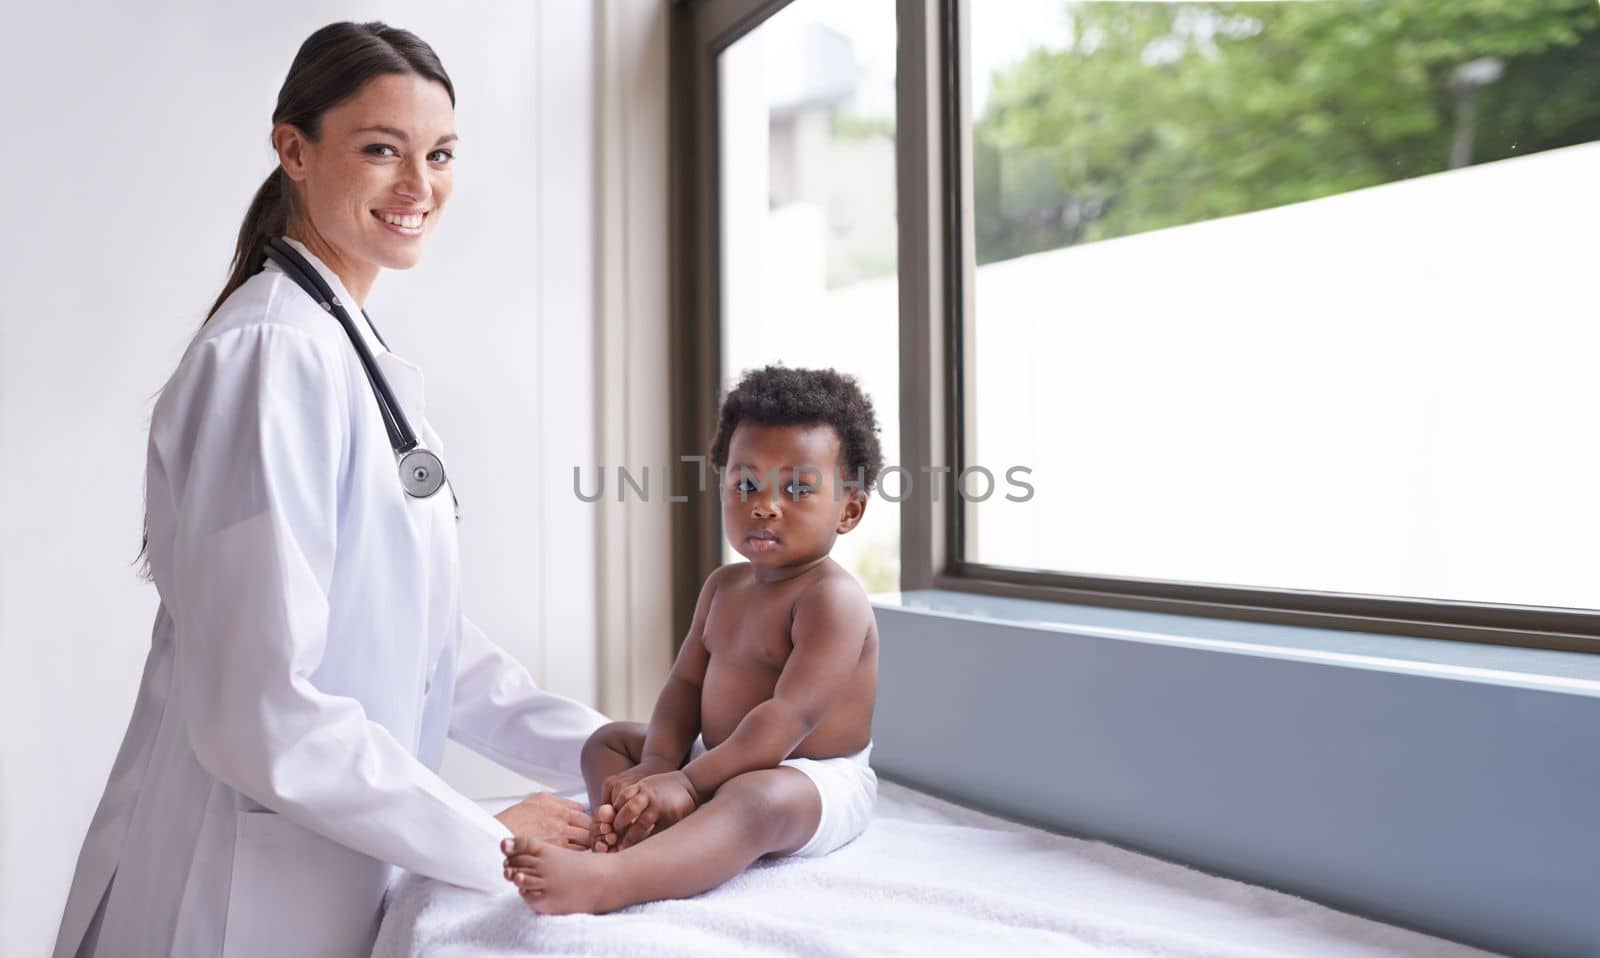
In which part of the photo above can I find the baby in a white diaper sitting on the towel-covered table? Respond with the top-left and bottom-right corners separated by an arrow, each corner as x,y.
504,366 -> 882,915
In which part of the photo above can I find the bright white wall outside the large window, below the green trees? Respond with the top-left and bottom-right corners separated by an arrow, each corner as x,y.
970,142 -> 1600,609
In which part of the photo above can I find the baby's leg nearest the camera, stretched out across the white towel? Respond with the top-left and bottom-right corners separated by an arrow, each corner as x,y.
510,768 -> 822,915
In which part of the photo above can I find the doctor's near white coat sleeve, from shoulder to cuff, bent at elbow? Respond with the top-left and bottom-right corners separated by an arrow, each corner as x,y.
162,323 -> 509,891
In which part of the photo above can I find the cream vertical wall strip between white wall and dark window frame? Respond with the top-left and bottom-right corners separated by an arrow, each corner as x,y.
595,0 -> 678,721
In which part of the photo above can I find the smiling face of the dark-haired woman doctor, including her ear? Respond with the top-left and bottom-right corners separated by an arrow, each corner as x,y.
272,74 -> 456,281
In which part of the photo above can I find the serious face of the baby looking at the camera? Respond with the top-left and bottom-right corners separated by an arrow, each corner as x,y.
722,422 -> 866,568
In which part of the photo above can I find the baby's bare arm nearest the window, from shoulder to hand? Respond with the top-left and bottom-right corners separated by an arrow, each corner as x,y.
683,576 -> 872,801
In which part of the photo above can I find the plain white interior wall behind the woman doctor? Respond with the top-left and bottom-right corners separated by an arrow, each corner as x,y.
0,0 -> 595,956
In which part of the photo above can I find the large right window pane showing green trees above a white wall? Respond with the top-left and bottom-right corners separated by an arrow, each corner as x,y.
940,0 -> 1600,646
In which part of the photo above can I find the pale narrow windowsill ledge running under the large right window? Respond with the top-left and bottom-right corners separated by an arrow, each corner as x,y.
872,589 -> 1600,697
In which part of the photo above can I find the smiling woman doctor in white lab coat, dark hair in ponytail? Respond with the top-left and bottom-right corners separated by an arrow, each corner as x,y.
56,22 -> 605,958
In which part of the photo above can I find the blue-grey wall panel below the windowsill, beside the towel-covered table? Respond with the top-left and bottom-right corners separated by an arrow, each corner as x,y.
872,606 -> 1600,955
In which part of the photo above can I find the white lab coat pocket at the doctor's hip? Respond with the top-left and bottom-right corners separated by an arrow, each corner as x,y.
222,811 -> 389,958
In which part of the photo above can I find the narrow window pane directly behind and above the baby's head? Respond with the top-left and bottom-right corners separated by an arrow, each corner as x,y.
717,0 -> 899,593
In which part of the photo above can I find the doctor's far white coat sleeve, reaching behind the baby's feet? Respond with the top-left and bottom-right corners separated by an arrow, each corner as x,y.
450,616 -> 606,792
